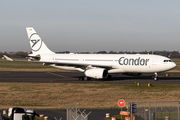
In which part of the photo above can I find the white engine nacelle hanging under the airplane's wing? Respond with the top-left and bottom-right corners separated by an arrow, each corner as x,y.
84,68 -> 108,79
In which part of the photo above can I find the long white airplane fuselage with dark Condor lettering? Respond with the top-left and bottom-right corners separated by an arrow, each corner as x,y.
40,54 -> 176,73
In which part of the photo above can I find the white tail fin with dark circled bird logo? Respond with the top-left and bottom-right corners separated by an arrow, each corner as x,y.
26,27 -> 54,55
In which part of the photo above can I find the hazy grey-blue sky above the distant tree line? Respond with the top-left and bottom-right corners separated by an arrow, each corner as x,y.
0,0 -> 180,52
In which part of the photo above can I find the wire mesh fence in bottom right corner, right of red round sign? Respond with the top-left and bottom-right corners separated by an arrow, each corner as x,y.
127,101 -> 180,120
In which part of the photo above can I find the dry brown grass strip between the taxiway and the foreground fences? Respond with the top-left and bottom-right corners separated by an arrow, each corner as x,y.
0,83 -> 180,109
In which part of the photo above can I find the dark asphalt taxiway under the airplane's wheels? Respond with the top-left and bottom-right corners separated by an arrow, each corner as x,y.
0,71 -> 180,84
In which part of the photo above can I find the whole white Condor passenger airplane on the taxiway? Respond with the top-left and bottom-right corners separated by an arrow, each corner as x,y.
4,27 -> 176,80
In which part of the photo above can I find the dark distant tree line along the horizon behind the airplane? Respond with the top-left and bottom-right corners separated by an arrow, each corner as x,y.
0,51 -> 180,58
